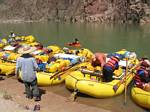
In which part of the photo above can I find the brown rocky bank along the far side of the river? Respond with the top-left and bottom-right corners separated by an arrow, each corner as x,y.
0,0 -> 150,24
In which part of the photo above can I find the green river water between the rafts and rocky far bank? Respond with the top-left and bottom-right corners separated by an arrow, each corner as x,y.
0,22 -> 150,58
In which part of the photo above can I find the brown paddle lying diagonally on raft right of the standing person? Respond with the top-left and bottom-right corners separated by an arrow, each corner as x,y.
50,62 -> 80,79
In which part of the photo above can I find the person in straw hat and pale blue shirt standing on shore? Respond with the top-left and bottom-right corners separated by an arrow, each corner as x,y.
15,45 -> 41,101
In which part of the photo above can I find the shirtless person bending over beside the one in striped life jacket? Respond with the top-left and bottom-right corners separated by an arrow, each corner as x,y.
92,52 -> 106,68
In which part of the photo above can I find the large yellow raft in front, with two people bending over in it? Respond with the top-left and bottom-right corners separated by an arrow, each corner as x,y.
65,50 -> 139,98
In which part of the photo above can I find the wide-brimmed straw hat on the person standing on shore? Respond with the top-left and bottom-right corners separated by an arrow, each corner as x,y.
18,45 -> 36,54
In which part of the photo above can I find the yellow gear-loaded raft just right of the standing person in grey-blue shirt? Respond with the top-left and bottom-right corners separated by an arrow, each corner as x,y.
19,54 -> 85,86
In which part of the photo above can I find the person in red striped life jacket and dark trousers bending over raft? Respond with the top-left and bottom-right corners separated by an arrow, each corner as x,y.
103,55 -> 120,82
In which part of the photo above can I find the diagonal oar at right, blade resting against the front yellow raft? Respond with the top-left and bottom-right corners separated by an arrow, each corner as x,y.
113,63 -> 141,92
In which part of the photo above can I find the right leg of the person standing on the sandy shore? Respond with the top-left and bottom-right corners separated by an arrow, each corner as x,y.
31,79 -> 41,101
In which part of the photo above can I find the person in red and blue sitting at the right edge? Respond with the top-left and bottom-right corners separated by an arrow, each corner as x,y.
134,58 -> 150,92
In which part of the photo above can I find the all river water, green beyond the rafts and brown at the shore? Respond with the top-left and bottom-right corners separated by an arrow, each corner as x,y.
0,22 -> 150,112
